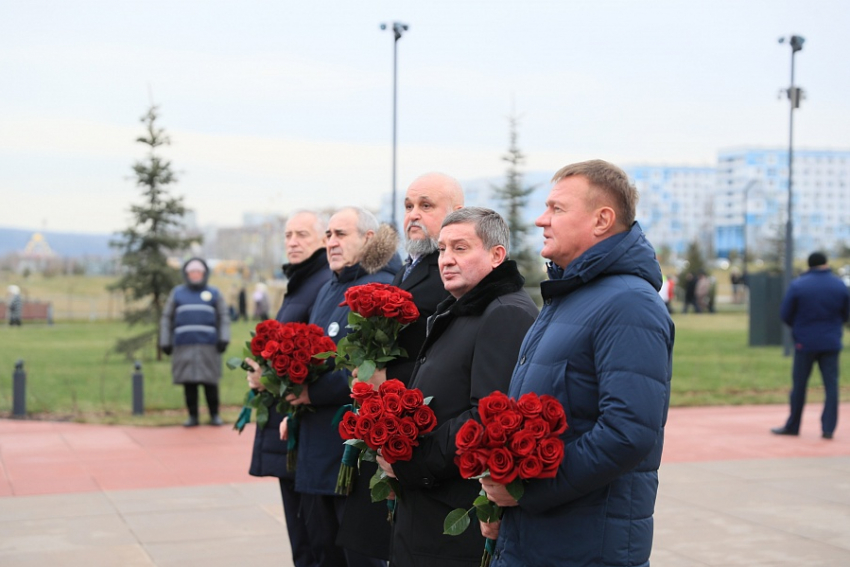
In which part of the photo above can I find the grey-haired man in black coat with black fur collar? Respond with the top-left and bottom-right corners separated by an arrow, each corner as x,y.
378,207 -> 537,567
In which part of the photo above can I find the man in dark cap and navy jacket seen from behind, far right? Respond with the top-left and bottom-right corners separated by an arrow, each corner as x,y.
771,252 -> 850,439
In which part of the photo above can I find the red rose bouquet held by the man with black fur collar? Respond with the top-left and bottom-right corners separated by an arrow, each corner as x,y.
336,379 -> 437,502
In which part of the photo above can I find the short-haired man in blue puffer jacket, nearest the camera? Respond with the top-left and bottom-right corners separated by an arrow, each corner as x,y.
481,160 -> 674,567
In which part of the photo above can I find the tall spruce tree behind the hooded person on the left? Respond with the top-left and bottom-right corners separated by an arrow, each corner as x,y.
109,106 -> 200,360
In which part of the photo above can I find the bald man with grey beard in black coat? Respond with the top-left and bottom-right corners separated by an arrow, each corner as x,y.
339,173 -> 463,559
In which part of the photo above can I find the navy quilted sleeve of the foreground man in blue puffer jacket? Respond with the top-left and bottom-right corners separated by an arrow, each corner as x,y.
519,293 -> 673,514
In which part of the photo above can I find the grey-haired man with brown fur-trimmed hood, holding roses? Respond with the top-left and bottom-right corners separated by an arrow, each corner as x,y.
288,207 -> 401,567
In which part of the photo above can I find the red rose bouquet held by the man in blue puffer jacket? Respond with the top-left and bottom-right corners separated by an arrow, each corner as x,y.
443,392 -> 569,566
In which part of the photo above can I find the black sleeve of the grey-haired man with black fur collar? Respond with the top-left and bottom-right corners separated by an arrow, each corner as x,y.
393,304 -> 534,487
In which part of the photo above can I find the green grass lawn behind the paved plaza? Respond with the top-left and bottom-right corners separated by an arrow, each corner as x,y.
0,312 -> 850,425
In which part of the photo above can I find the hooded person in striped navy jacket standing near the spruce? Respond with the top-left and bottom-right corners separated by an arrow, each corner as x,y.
159,258 -> 230,427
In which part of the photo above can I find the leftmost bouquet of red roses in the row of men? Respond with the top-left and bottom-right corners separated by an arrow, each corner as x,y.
227,319 -> 336,470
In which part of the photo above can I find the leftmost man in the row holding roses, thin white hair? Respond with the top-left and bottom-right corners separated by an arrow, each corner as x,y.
245,211 -> 331,567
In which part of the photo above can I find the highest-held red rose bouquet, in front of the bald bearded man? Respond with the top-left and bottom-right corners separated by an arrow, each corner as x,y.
337,283 -> 419,381
